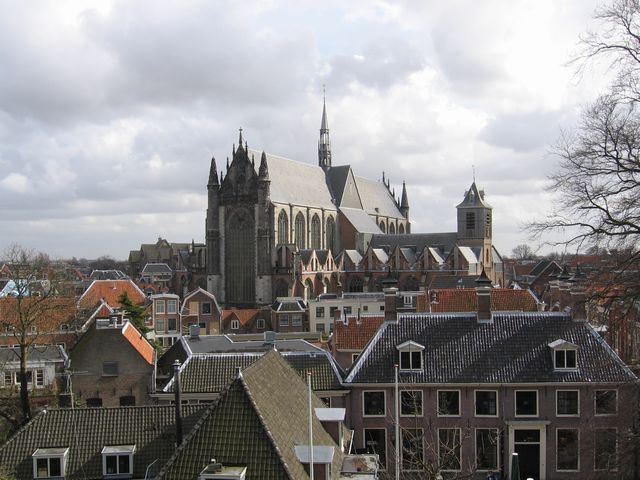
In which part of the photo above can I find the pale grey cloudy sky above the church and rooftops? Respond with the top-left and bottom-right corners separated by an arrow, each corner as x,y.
0,0 -> 604,259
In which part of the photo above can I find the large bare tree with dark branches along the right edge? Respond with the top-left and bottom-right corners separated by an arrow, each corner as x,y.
529,0 -> 640,300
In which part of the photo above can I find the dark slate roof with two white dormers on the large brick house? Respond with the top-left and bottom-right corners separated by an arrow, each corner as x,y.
346,312 -> 636,384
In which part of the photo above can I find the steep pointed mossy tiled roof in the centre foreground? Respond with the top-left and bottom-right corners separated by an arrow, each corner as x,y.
159,351 -> 343,480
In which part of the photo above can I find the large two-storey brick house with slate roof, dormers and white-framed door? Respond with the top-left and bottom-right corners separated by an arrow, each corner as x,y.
345,286 -> 637,480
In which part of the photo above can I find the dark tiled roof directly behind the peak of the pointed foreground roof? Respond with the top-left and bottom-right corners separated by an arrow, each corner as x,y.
163,351 -> 344,393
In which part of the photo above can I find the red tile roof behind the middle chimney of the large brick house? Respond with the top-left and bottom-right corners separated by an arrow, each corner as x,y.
428,288 -> 537,313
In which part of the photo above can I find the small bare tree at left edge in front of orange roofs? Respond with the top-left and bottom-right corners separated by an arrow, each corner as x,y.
0,244 -> 74,423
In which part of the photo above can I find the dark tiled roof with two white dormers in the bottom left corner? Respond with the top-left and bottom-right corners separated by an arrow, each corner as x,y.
0,405 -> 205,480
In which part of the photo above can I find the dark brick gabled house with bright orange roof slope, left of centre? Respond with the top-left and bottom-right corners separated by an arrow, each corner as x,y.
70,316 -> 156,407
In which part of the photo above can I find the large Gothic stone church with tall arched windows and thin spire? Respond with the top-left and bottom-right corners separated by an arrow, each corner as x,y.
206,102 -> 502,307
